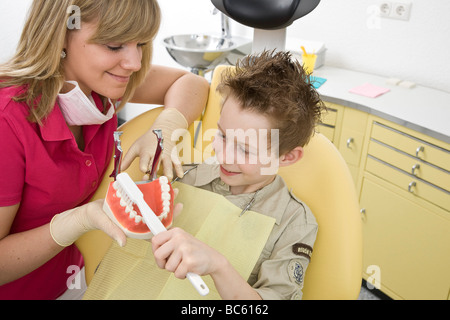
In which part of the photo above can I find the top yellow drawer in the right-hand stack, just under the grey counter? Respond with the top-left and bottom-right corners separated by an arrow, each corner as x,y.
372,122 -> 450,171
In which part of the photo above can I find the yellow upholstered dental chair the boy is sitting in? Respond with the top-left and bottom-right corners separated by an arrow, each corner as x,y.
76,66 -> 362,300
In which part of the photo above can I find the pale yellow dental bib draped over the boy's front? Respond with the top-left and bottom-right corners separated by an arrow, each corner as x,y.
84,183 -> 275,300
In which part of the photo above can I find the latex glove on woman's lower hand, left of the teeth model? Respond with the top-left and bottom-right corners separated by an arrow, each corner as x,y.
50,200 -> 126,247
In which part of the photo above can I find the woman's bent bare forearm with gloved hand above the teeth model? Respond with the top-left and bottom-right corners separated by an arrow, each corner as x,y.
122,65 -> 209,180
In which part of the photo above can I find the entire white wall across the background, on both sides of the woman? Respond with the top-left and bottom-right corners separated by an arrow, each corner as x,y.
0,0 -> 450,92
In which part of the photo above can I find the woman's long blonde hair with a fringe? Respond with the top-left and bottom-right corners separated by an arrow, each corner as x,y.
0,0 -> 161,124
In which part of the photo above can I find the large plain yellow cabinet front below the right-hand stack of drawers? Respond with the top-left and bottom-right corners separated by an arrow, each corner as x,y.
360,177 -> 450,299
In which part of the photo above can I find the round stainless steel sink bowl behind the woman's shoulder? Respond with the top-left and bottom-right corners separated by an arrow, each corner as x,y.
163,34 -> 251,75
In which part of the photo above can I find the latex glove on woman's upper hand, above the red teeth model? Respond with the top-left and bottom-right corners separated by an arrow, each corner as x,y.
121,108 -> 188,181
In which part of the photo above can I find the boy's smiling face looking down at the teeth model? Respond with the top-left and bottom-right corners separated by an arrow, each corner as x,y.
213,96 -> 278,194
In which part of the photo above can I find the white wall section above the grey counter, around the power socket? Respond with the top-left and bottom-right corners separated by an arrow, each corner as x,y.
289,0 -> 450,92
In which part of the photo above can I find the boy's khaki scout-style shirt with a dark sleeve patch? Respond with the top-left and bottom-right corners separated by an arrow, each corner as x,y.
181,164 -> 318,300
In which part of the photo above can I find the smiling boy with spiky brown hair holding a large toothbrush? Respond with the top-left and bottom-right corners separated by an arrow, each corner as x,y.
152,51 -> 324,300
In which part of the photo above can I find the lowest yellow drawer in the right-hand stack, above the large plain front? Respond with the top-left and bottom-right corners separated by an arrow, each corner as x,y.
366,155 -> 450,211
